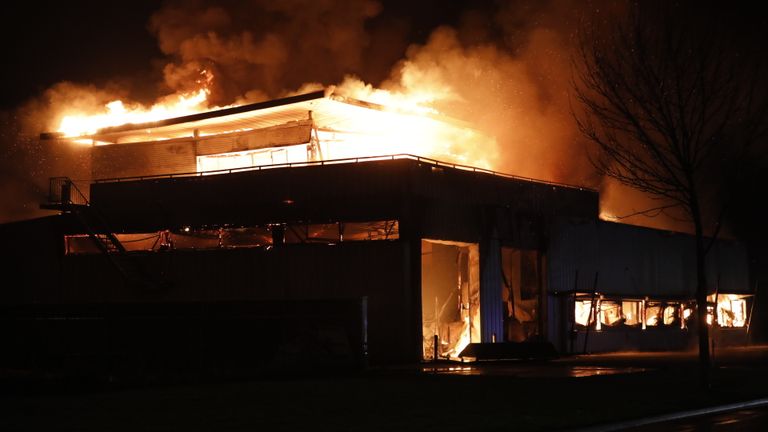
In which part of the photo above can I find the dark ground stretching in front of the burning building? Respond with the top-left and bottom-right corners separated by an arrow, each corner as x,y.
0,347 -> 768,432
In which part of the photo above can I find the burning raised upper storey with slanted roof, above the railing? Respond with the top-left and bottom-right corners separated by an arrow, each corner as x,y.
42,88 -> 496,179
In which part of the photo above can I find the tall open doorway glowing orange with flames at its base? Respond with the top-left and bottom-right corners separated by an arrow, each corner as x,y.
421,239 -> 480,360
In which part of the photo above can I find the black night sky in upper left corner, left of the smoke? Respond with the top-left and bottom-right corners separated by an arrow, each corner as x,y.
0,1 -> 162,109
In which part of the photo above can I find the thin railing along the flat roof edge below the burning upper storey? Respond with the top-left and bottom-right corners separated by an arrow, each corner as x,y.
94,153 -> 596,192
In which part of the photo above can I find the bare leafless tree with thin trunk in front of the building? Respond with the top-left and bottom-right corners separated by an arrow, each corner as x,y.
574,2 -> 766,386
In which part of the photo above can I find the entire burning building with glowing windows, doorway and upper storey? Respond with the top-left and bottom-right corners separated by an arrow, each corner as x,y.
0,91 -> 753,374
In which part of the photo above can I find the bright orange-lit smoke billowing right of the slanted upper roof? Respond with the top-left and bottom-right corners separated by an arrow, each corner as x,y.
383,28 -> 588,183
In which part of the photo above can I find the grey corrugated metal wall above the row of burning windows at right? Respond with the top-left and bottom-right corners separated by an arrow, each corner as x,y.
549,220 -> 750,297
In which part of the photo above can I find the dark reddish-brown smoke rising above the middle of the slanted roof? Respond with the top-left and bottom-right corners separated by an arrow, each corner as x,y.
150,0 -> 388,105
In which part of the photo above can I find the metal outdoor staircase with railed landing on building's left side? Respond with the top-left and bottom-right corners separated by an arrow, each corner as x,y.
40,177 -> 160,288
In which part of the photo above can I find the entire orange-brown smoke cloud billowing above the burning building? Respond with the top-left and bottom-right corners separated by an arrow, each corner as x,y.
6,0 -> 623,223
